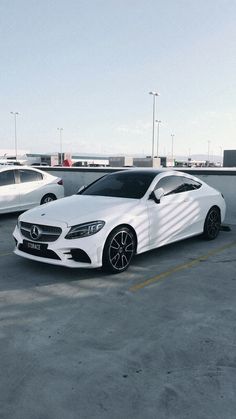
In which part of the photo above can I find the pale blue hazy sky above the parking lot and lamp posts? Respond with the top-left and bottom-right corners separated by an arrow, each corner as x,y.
0,0 -> 236,155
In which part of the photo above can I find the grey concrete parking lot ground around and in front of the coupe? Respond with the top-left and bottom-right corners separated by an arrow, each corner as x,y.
0,214 -> 236,419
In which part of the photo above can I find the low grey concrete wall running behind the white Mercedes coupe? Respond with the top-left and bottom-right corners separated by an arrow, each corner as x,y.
40,167 -> 236,224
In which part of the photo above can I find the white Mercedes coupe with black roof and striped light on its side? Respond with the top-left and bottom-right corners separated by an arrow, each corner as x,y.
13,169 -> 226,273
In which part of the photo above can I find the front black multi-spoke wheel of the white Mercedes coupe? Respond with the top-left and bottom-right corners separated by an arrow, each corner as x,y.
103,227 -> 136,273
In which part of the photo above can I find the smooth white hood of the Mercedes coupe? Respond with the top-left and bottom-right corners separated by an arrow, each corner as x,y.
21,195 -> 140,226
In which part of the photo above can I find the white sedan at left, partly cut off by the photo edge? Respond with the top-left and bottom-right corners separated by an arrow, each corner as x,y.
0,165 -> 64,214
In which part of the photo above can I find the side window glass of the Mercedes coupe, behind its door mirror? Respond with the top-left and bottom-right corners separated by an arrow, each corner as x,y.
155,176 -> 202,195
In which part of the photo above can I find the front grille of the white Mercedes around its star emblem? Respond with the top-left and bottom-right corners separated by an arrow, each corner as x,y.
20,221 -> 62,242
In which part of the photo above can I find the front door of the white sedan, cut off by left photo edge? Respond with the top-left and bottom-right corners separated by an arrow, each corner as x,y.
0,170 -> 20,213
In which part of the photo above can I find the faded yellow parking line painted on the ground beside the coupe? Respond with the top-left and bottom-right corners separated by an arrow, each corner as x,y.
129,242 -> 236,292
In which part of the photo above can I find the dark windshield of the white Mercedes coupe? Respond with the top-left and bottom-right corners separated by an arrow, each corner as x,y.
80,170 -> 157,199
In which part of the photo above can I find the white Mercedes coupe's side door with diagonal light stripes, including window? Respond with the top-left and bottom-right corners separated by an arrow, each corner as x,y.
147,175 -> 201,247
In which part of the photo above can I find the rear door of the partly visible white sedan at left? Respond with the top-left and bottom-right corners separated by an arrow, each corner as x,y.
17,168 -> 44,209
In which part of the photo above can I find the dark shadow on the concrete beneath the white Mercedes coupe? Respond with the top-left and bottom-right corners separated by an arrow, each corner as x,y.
0,220 -> 232,291
